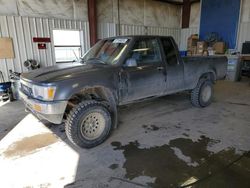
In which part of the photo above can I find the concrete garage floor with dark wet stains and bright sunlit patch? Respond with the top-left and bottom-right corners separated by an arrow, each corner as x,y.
0,81 -> 250,188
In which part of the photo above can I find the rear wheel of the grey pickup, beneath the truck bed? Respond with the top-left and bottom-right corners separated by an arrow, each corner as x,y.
191,79 -> 213,107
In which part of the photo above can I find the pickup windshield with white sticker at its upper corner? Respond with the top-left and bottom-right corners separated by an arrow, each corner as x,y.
82,38 -> 129,65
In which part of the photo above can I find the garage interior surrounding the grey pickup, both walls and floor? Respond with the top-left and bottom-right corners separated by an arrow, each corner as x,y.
0,0 -> 250,188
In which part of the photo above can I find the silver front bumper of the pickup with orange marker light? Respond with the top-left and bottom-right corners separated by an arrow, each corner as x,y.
19,91 -> 67,124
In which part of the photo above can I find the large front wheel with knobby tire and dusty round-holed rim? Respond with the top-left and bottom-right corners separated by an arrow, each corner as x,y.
65,100 -> 112,148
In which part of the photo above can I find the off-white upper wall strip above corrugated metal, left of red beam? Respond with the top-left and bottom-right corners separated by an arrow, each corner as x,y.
0,0 -> 88,21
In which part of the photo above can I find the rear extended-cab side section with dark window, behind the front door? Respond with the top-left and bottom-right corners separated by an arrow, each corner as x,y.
161,37 -> 184,94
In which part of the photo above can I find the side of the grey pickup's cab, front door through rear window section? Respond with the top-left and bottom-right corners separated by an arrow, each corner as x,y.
118,36 -> 184,103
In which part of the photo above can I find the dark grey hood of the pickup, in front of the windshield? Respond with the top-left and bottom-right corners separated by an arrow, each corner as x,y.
21,63 -> 111,83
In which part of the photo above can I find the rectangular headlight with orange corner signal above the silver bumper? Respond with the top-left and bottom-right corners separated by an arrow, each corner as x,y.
32,85 -> 56,101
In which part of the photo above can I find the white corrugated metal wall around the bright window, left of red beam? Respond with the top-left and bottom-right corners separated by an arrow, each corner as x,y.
0,16 -> 90,80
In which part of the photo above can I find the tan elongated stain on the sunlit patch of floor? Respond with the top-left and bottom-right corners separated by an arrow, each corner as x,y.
3,133 -> 58,157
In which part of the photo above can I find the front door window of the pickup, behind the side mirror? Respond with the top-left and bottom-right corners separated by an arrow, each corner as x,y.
128,39 -> 161,65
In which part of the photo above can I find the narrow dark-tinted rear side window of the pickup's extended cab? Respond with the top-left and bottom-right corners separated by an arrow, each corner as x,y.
161,38 -> 178,66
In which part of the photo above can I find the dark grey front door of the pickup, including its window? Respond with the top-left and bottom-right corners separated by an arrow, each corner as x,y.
121,37 -> 166,103
